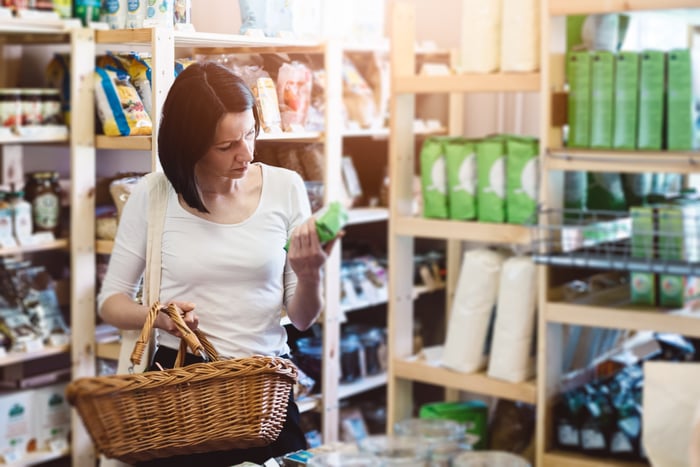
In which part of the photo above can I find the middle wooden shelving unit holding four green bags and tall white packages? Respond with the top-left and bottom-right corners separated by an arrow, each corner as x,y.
387,2 -> 541,446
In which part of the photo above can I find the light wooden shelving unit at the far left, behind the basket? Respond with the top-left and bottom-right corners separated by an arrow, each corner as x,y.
0,18 -> 95,465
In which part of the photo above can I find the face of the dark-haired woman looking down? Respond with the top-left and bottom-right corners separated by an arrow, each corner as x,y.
196,109 -> 255,179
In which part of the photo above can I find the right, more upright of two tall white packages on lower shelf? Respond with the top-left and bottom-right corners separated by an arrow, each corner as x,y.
488,256 -> 537,383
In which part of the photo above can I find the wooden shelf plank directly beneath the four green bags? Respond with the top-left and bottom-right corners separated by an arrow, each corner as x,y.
390,217 -> 532,244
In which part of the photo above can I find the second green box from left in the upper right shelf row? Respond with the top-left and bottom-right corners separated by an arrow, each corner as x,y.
590,51 -> 615,148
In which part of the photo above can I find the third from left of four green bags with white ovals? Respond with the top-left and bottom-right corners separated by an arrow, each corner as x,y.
476,136 -> 506,222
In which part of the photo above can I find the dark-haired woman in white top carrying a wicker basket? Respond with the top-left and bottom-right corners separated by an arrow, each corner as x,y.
98,63 -> 335,466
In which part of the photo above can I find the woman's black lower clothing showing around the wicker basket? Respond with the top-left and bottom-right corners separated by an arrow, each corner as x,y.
136,346 -> 307,467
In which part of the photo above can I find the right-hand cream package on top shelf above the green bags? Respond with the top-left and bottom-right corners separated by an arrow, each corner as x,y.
501,0 -> 540,72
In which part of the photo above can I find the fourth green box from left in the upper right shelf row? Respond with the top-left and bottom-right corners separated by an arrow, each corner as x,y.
637,50 -> 666,150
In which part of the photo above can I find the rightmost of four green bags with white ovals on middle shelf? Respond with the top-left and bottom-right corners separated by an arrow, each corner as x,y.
506,137 -> 540,224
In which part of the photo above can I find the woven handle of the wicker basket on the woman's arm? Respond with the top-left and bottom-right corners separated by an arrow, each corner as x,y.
131,302 -> 219,367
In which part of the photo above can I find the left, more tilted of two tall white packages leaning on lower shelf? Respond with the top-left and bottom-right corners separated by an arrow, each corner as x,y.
442,249 -> 505,373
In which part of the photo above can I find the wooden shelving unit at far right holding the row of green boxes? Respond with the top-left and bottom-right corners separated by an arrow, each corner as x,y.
536,0 -> 700,467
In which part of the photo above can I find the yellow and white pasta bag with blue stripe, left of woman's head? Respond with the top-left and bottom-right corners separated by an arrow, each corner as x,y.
95,67 -> 153,136
